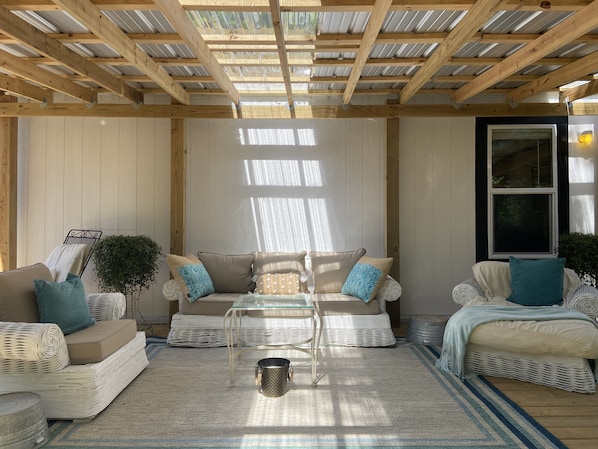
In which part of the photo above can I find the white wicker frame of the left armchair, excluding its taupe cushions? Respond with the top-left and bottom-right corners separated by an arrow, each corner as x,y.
0,293 -> 148,421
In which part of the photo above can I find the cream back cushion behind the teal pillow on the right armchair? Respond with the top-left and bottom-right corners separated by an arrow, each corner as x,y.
472,260 -> 581,300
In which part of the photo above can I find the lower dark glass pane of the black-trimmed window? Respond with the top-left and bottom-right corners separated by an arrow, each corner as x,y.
493,194 -> 553,254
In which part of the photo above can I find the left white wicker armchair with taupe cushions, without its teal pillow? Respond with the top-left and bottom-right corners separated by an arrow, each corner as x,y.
0,263 -> 148,421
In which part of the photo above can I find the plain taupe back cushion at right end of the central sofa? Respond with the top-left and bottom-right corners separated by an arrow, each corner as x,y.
309,248 -> 365,293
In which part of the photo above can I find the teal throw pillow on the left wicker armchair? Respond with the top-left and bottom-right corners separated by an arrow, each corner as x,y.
33,274 -> 96,335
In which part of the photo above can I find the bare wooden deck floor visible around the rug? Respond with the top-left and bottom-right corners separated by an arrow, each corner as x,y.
153,324 -> 598,449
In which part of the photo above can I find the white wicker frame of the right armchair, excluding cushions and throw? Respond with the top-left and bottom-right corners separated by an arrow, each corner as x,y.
452,262 -> 598,393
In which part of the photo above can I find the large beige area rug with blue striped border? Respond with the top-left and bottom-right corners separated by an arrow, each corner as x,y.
46,339 -> 565,449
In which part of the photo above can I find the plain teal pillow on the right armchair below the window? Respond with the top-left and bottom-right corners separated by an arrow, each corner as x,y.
507,257 -> 565,306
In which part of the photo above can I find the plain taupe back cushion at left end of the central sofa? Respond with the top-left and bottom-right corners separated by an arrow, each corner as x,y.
197,252 -> 255,293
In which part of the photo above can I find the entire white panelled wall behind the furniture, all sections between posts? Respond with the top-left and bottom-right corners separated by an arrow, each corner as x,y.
18,106 -> 598,320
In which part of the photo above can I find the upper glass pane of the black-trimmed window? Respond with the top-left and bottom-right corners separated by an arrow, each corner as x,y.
492,128 -> 553,188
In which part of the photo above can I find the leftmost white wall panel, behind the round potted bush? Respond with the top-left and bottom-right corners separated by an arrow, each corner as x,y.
17,112 -> 170,320
